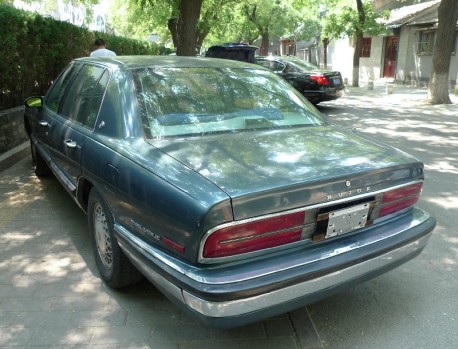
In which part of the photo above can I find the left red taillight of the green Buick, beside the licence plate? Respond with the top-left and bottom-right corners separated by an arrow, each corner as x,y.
202,211 -> 305,258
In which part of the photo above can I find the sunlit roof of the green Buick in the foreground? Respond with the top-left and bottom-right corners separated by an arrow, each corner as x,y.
75,55 -> 260,69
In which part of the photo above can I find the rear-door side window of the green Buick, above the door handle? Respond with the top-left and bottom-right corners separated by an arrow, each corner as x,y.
60,64 -> 108,128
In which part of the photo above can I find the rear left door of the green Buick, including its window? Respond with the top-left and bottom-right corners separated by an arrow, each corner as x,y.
50,64 -> 109,194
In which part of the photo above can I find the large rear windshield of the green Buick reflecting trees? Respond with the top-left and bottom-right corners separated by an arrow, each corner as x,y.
133,68 -> 326,139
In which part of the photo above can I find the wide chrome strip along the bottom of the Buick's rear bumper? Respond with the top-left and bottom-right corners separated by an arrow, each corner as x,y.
183,233 -> 432,318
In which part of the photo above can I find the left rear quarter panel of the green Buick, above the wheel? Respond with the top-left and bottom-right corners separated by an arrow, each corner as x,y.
82,135 -> 232,262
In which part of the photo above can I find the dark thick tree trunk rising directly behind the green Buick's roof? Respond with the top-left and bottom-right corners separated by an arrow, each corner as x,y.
177,0 -> 203,56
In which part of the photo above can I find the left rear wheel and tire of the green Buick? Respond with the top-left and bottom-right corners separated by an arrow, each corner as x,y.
88,188 -> 142,288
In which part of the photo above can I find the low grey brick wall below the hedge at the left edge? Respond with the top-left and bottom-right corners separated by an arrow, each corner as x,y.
0,107 -> 28,154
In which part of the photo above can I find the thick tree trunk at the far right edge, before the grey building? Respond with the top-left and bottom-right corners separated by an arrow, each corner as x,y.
427,0 -> 458,104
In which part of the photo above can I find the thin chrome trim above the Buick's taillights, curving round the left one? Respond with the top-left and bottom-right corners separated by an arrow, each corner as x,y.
198,180 -> 423,264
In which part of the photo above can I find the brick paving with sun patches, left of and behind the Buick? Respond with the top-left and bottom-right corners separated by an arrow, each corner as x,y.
0,157 -> 322,349
